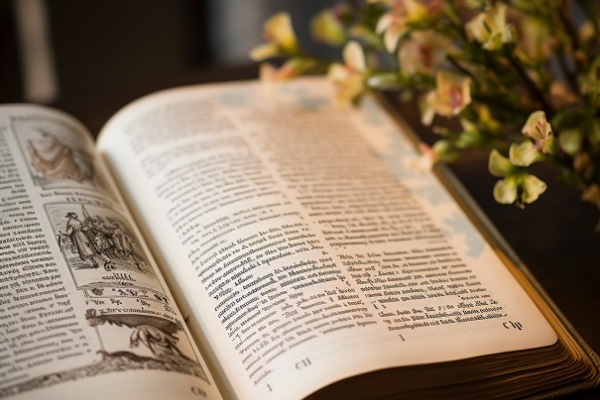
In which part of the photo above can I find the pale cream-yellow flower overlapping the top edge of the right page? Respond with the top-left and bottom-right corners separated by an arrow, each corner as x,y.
328,41 -> 367,104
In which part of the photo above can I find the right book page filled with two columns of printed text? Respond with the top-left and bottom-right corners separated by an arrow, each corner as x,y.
99,78 -> 557,399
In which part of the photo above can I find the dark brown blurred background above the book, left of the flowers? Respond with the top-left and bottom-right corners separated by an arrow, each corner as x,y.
0,0 -> 337,132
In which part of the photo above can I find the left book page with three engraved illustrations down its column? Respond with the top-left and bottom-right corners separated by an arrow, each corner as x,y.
0,106 -> 220,399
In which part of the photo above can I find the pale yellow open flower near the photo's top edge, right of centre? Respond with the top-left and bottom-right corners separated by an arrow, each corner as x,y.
466,3 -> 514,50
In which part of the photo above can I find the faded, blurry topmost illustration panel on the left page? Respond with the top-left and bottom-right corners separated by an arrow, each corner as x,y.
12,116 -> 100,188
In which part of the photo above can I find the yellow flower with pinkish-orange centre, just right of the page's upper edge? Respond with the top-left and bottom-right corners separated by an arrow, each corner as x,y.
421,71 -> 471,125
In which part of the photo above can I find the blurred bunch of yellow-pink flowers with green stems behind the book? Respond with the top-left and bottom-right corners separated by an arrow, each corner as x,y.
250,0 -> 600,229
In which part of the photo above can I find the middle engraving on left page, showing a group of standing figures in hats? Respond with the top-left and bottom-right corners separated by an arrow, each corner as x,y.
46,203 -> 168,302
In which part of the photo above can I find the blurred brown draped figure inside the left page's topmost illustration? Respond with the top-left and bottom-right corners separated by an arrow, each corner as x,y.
28,131 -> 92,182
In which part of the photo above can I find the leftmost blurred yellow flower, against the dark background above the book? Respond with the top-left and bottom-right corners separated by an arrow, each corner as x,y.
250,12 -> 299,61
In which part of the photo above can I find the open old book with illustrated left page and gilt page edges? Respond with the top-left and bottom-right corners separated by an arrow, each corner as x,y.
0,78 -> 599,400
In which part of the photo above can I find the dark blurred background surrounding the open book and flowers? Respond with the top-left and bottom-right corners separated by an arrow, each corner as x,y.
0,0 -> 600,399
